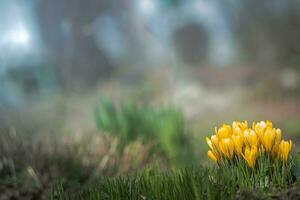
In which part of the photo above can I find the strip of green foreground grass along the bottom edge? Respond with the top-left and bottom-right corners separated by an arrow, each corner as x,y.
51,162 -> 298,200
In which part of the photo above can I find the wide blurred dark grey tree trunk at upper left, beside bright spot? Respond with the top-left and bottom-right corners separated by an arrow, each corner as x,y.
37,0 -> 114,89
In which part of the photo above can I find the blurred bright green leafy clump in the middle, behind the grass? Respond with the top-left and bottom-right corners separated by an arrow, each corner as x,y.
95,98 -> 194,164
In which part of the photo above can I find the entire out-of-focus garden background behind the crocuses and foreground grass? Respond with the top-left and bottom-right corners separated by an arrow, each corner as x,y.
0,0 -> 300,198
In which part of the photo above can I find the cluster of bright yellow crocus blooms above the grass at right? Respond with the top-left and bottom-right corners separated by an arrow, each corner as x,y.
206,121 -> 292,167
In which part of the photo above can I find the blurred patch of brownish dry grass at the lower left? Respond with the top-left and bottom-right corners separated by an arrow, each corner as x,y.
0,127 -> 155,199
